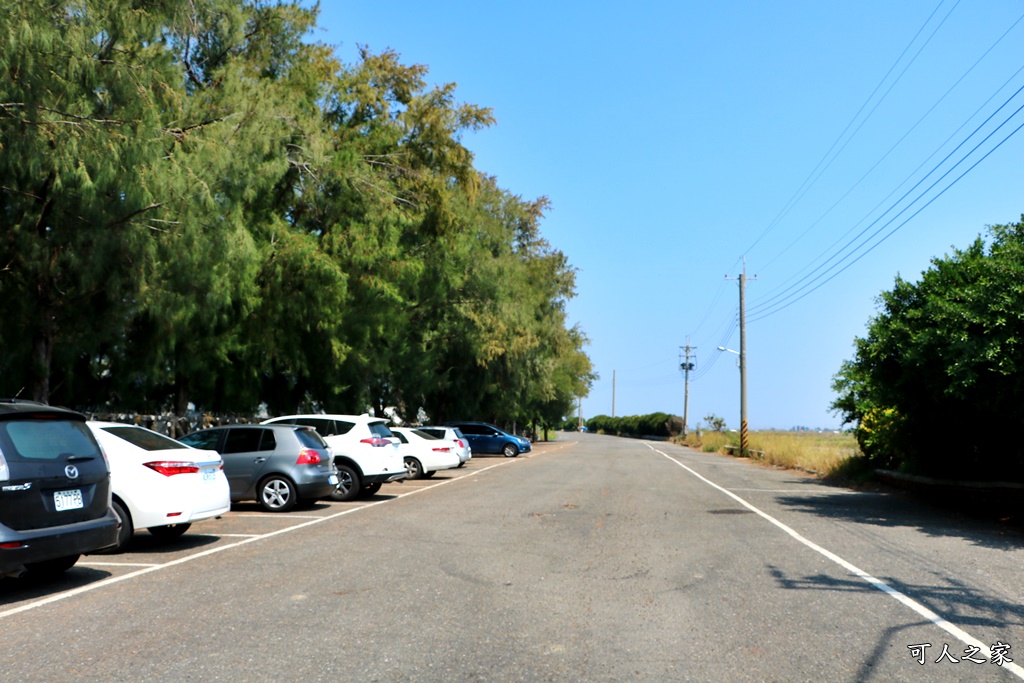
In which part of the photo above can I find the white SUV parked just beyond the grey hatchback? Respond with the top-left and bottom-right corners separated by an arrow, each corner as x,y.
263,414 -> 406,501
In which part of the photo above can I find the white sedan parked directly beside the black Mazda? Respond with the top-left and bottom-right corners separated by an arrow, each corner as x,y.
87,421 -> 231,553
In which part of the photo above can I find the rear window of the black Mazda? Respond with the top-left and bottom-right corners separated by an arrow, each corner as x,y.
0,420 -> 100,460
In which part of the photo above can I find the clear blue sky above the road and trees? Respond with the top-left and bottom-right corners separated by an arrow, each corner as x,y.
314,0 -> 1024,429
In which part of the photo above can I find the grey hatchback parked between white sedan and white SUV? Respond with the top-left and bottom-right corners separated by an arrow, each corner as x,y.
181,425 -> 338,512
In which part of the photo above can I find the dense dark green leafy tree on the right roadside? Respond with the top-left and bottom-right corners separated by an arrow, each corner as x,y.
833,223 -> 1024,479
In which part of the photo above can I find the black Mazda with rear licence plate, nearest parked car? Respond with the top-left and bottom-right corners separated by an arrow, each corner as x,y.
0,398 -> 121,578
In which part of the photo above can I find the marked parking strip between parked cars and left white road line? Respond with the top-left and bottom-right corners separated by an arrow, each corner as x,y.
0,443 -> 556,618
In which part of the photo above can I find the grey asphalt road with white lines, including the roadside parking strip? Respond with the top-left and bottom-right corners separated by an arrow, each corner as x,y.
0,433 -> 1024,682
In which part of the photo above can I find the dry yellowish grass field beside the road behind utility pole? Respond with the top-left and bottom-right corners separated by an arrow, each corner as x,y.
686,431 -> 861,476
